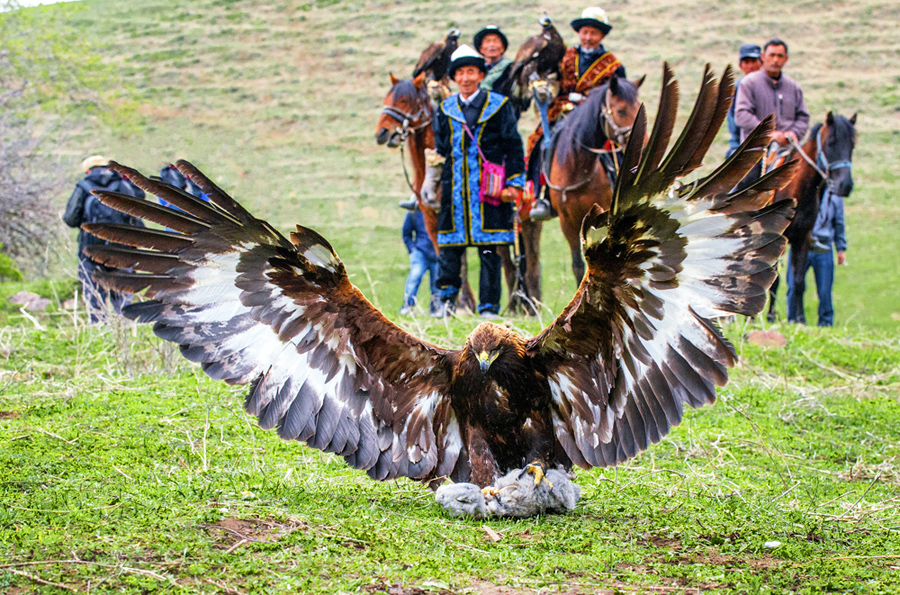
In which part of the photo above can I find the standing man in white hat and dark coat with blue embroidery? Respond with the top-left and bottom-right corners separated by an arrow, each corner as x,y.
434,45 -> 525,318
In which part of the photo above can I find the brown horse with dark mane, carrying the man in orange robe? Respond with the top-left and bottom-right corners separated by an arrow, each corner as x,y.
543,77 -> 644,283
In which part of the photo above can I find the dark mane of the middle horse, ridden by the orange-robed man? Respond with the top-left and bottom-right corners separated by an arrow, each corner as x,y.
550,78 -> 638,162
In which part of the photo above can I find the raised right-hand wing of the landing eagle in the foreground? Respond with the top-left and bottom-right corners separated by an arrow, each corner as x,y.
528,65 -> 793,467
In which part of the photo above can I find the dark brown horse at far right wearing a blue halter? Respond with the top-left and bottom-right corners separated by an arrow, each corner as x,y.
767,112 -> 856,324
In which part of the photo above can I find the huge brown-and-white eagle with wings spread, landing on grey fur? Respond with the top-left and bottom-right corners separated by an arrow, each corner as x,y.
84,66 -> 793,516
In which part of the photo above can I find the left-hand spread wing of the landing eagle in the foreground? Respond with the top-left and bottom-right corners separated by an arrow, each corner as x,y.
85,161 -> 461,479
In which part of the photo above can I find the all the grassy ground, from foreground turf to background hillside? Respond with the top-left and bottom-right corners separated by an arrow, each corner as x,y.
0,0 -> 900,595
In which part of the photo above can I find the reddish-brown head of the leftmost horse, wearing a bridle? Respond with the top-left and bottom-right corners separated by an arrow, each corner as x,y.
375,73 -> 431,148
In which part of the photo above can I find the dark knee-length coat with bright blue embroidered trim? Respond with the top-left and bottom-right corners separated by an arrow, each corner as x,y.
434,90 -> 525,246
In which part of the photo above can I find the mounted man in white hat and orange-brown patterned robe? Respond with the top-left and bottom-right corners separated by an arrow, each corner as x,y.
528,6 -> 625,221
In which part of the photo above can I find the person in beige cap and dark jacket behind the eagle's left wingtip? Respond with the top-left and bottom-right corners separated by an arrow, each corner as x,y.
63,155 -> 144,322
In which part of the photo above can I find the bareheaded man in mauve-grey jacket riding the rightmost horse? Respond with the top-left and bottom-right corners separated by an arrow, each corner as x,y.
734,38 -> 809,189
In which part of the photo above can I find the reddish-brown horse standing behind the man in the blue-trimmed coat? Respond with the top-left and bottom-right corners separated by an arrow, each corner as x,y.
375,73 -> 516,311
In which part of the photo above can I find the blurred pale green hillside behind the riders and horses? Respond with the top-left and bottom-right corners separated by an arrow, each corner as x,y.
31,0 -> 900,330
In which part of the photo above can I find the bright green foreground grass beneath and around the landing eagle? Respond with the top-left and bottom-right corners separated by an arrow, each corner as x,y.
0,310 -> 900,595
